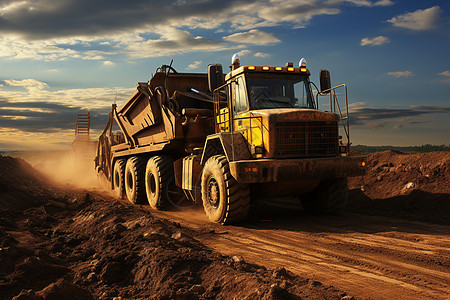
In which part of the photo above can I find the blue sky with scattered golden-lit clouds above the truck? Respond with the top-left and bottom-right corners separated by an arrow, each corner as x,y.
0,0 -> 450,151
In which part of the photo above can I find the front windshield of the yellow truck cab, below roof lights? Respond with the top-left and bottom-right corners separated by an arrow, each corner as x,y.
246,73 -> 315,109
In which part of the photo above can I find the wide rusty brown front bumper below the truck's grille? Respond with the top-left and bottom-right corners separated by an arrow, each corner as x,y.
230,156 -> 365,183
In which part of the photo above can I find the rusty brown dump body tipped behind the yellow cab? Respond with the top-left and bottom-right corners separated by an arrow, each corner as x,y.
95,71 -> 214,182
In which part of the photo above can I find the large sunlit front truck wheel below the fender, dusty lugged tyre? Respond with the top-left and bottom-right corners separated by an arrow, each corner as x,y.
202,155 -> 250,224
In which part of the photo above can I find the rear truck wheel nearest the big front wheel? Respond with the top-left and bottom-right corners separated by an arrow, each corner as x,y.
145,156 -> 174,210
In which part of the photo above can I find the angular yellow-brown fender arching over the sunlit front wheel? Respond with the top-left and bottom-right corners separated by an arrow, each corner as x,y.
200,132 -> 252,165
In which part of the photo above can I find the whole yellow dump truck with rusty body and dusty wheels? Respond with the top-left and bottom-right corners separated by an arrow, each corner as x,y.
95,55 -> 365,224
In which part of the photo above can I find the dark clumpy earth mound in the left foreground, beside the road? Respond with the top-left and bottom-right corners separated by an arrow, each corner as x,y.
0,156 -> 352,299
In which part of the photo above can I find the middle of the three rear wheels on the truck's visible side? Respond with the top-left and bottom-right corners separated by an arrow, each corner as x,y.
124,156 -> 146,204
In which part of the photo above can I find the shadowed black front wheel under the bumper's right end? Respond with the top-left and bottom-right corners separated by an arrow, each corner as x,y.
300,178 -> 348,215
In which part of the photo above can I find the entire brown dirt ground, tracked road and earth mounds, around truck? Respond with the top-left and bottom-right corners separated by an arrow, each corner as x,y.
0,151 -> 450,299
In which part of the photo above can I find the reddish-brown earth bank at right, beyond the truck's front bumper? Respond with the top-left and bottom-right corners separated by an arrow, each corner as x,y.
347,150 -> 450,224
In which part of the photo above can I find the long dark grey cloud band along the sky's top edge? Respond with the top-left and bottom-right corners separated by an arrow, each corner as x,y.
0,0 -> 342,43
